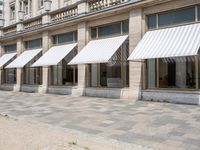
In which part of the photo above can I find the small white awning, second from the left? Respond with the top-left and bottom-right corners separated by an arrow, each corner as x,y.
5,49 -> 42,68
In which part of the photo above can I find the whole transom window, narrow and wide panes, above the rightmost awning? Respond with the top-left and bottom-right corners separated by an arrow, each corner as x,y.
147,6 -> 196,29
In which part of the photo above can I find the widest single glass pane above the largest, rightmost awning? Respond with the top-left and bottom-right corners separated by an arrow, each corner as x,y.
158,7 -> 195,27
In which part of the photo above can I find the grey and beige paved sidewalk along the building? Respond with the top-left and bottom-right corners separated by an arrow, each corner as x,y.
0,91 -> 200,150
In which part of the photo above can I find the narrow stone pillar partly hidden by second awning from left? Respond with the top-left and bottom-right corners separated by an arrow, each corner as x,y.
14,38 -> 24,92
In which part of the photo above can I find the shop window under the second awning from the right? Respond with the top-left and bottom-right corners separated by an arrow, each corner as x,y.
89,41 -> 129,88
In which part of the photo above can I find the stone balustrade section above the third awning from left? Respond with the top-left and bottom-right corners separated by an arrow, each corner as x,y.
51,6 -> 78,22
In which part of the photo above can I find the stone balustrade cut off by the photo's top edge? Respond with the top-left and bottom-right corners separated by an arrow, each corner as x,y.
88,0 -> 128,11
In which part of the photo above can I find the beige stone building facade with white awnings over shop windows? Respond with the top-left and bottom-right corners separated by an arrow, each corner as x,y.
0,0 -> 200,104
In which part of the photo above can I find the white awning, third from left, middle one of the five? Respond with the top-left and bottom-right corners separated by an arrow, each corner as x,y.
31,43 -> 77,67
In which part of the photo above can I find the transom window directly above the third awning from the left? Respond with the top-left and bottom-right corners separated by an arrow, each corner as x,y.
53,31 -> 77,45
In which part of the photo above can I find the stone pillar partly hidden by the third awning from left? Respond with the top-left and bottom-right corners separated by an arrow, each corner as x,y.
39,32 -> 50,93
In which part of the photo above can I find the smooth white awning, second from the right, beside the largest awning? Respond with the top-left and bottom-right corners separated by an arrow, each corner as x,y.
69,35 -> 128,65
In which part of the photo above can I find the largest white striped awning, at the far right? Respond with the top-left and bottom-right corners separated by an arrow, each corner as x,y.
128,23 -> 200,60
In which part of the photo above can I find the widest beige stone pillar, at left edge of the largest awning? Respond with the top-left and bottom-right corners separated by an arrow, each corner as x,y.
129,8 -> 143,100
